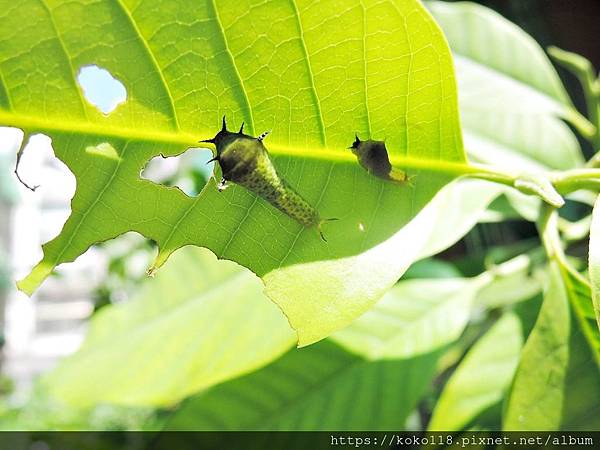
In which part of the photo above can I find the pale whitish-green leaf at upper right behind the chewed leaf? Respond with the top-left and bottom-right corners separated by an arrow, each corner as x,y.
427,1 -> 593,172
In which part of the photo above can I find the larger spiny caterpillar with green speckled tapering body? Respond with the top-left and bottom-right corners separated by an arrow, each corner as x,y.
200,116 -> 336,241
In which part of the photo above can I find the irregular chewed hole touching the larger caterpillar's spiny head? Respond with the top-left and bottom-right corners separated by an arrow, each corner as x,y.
141,149 -> 214,197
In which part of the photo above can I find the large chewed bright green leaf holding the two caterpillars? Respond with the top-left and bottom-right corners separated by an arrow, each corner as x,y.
0,0 -> 464,345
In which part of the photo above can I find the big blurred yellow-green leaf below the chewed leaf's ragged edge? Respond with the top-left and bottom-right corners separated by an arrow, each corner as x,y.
44,248 -> 294,407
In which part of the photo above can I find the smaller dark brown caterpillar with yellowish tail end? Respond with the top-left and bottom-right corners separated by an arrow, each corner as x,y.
348,135 -> 409,183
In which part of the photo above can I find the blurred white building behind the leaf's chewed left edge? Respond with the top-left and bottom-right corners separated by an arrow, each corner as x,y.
0,128 -> 105,395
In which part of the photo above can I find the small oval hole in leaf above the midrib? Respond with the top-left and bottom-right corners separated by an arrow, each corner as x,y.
77,65 -> 127,114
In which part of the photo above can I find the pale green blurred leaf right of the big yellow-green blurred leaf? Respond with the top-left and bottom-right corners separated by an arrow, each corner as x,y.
332,278 -> 484,359
